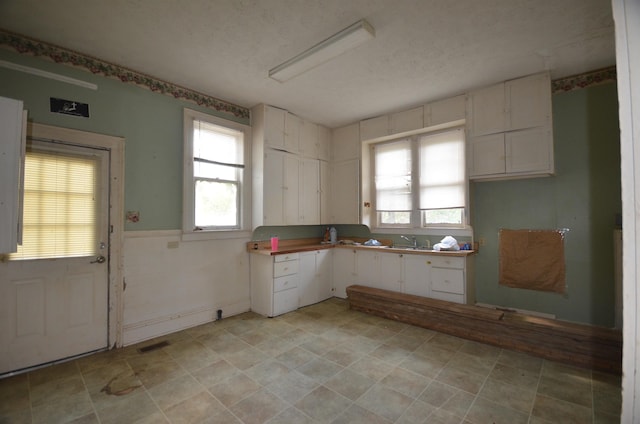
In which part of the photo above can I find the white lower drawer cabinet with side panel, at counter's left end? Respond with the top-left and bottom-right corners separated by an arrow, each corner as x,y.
250,253 -> 300,317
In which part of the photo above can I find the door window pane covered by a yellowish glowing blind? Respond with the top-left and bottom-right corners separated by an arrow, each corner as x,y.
9,149 -> 100,260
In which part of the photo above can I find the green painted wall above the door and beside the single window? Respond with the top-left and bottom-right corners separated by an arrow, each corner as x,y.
0,49 -> 247,230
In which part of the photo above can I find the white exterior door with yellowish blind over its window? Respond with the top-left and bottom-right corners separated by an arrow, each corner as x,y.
0,140 -> 109,374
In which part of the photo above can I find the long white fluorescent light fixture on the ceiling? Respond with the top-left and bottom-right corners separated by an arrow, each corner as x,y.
269,19 -> 375,82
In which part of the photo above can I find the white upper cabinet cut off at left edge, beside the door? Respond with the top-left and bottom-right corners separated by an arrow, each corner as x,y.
0,97 -> 26,253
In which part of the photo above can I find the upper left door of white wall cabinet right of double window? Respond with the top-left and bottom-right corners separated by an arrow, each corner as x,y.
469,83 -> 505,136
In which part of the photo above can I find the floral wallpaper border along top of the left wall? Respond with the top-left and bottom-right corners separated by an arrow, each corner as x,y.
0,29 -> 249,120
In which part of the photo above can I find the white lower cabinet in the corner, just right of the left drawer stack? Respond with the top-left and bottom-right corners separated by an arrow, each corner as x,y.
298,250 -> 332,307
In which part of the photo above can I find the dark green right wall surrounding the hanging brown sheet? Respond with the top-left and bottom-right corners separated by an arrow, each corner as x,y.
471,84 -> 622,327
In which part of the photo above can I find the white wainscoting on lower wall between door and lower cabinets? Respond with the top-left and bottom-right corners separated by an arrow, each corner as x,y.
123,231 -> 251,346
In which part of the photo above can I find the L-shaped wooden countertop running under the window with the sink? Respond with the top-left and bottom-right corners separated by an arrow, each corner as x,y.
247,238 -> 477,257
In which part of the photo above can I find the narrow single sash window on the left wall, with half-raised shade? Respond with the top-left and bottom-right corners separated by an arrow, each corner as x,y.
184,109 -> 247,232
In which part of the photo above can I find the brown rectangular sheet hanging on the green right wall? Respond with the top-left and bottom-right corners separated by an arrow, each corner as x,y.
499,229 -> 565,293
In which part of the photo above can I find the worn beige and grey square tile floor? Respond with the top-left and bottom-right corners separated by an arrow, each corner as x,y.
0,298 -> 621,424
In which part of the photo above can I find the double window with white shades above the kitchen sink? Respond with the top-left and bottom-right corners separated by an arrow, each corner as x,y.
371,128 -> 467,228
